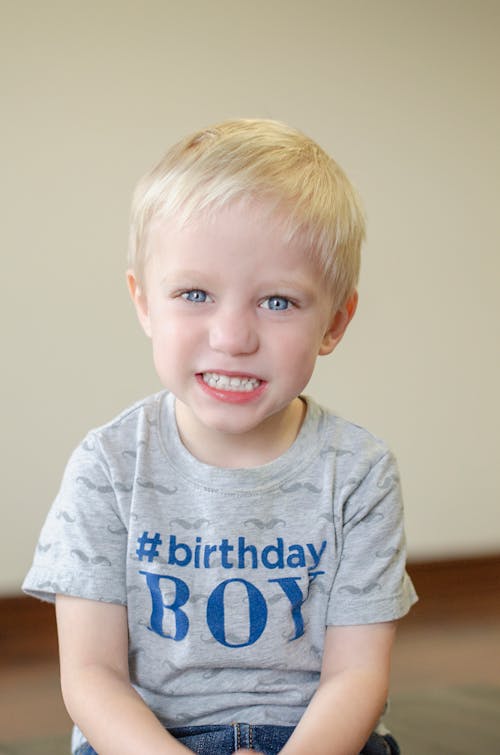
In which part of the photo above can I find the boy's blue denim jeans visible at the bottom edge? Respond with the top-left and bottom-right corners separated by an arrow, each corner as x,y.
76,724 -> 400,755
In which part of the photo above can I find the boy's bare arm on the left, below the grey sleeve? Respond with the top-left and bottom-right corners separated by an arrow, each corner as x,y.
56,595 -> 190,755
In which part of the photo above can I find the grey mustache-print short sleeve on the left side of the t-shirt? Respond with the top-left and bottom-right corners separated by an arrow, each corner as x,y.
23,434 -> 127,604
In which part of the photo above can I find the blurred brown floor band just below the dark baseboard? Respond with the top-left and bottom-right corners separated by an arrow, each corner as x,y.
0,621 -> 500,744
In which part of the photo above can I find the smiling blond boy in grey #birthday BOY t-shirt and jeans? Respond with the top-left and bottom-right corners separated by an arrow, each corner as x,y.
24,120 -> 416,755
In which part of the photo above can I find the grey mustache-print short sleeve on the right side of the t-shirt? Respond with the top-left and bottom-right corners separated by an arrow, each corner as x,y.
327,452 -> 417,625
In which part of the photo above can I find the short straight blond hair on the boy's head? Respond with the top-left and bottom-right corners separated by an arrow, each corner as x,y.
129,119 -> 365,307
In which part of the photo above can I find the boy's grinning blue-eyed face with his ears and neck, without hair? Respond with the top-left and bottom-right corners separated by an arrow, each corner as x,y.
129,204 -> 355,460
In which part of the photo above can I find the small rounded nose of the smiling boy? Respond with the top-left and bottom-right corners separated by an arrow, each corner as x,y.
209,307 -> 259,356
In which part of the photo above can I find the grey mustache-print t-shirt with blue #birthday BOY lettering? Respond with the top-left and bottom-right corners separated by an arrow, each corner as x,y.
23,392 -> 416,748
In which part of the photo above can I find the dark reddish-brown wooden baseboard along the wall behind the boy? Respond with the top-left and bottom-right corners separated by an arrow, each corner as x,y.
0,554 -> 500,664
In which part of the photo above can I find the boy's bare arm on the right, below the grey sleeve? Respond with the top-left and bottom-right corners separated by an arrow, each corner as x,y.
281,622 -> 395,755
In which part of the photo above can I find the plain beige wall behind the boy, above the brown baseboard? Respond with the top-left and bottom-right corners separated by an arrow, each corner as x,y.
0,0 -> 500,593
